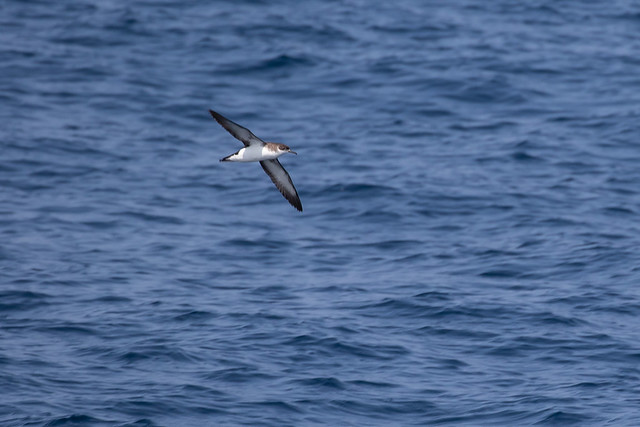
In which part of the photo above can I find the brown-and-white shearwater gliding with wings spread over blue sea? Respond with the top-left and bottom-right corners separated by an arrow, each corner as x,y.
209,110 -> 302,212
